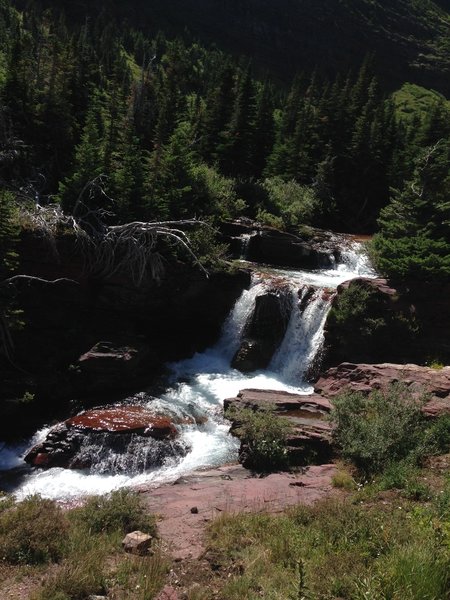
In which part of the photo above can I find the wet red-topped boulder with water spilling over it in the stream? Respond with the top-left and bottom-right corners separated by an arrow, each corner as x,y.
25,406 -> 188,473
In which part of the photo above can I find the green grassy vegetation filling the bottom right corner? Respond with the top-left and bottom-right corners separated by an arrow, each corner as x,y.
205,487 -> 450,600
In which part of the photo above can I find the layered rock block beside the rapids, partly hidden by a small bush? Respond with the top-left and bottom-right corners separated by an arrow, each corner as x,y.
224,389 -> 332,466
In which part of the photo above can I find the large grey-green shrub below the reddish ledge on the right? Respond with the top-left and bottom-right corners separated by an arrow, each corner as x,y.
331,384 -> 425,476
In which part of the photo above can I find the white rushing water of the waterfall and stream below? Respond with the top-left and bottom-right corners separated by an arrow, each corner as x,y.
0,243 -> 375,499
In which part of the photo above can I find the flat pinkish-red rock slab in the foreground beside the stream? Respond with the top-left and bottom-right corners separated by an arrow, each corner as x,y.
138,465 -> 337,560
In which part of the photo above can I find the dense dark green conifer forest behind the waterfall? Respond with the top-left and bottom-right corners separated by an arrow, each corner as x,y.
0,0 -> 450,280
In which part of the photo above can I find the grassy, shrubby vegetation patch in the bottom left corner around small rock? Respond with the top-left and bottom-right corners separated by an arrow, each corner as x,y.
0,490 -> 168,600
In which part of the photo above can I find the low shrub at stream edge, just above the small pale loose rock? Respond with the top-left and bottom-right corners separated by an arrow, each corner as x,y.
71,489 -> 156,535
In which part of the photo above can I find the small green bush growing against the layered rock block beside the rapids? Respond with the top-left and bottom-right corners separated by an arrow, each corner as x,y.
226,408 -> 290,471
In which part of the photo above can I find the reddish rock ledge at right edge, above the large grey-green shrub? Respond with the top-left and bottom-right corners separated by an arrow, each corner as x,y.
314,363 -> 450,416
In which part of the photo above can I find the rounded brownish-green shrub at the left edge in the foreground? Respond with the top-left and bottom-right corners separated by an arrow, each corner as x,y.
0,496 -> 68,564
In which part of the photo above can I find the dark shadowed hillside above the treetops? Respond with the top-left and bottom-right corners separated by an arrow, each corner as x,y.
22,0 -> 450,95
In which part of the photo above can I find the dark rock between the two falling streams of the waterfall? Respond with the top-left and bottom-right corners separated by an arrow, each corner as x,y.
231,287 -> 292,373
